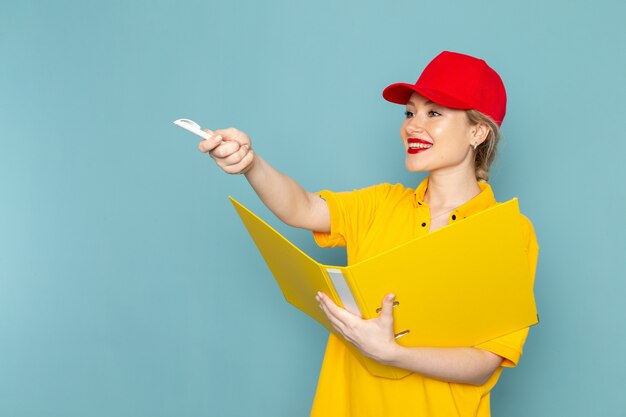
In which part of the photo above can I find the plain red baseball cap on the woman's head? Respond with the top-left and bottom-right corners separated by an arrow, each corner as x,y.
383,51 -> 506,126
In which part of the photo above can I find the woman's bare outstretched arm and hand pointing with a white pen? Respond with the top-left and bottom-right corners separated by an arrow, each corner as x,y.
198,128 -> 330,232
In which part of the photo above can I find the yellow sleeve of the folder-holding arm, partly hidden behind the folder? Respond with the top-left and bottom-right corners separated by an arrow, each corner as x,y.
475,216 -> 539,368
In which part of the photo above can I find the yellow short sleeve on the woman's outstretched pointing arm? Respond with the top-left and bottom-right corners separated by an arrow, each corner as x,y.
313,184 -> 390,248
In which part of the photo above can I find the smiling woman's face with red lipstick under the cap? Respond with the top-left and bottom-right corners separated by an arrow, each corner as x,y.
400,93 -> 484,173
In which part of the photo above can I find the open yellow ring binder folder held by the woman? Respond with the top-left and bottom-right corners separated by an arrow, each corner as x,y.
230,198 -> 538,379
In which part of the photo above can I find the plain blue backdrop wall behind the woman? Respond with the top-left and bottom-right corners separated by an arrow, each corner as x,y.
0,0 -> 626,417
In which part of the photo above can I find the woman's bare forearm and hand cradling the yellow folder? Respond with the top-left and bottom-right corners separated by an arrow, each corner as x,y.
317,293 -> 502,385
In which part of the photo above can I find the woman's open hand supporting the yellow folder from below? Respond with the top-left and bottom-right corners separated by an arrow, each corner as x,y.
316,292 -> 399,364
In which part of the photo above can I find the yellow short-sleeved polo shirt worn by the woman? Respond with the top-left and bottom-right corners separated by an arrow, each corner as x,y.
311,178 -> 539,417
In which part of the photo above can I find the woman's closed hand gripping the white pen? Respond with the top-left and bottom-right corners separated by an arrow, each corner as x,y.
198,128 -> 254,174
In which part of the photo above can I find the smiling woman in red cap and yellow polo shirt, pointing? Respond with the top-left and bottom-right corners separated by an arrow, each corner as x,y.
199,51 -> 538,417
